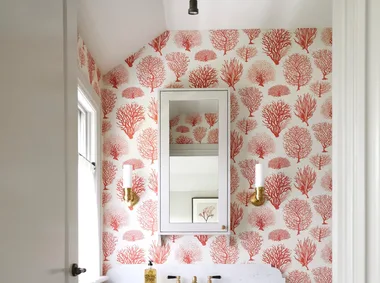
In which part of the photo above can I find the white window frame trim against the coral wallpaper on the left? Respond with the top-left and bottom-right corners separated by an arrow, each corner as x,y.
77,69 -> 104,283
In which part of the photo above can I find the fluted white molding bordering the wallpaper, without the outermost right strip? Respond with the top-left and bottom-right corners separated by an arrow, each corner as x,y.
333,0 -> 366,283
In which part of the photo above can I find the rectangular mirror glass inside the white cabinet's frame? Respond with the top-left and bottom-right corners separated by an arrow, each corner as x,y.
169,100 -> 219,223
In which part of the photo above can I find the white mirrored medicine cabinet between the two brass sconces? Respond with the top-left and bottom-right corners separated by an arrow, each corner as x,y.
159,89 -> 230,235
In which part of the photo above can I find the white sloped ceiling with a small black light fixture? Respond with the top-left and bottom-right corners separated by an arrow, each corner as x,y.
78,0 -> 332,72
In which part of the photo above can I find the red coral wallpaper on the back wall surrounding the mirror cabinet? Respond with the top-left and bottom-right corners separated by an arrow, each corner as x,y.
101,28 -> 332,283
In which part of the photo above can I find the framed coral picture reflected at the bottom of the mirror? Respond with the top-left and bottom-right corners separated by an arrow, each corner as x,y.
192,197 -> 218,223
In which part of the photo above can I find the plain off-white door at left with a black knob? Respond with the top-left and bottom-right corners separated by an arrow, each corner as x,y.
0,0 -> 77,283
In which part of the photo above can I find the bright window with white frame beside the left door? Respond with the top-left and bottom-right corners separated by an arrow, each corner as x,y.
78,87 -> 101,283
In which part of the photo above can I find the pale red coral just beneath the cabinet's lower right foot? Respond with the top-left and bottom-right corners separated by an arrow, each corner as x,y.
210,235 -> 239,264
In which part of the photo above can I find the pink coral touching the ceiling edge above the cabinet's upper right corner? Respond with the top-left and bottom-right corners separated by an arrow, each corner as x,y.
210,29 -> 239,55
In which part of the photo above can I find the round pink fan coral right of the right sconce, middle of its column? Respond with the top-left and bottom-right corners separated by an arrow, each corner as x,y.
284,126 -> 312,163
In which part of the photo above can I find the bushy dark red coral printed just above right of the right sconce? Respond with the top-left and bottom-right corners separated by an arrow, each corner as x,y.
262,100 -> 292,138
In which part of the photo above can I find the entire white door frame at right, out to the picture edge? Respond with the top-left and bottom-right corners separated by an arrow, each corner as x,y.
332,0 -> 380,283
